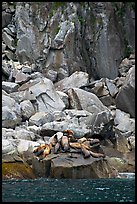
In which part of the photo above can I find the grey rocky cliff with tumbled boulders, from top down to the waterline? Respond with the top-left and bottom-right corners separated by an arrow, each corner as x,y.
2,2 -> 135,178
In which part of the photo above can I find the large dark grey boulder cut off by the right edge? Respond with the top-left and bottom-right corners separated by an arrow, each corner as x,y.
115,66 -> 135,118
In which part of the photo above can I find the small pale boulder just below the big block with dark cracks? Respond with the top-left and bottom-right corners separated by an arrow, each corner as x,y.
29,112 -> 53,126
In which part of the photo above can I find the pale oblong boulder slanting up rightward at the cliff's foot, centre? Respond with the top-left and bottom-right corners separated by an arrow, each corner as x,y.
55,71 -> 89,92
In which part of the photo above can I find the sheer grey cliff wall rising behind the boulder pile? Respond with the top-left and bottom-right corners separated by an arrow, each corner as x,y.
3,2 -> 135,80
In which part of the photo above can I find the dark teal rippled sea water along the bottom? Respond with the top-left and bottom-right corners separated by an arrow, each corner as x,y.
2,178 -> 135,202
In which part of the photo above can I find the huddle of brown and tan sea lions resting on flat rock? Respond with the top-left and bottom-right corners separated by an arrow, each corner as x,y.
33,130 -> 105,160
